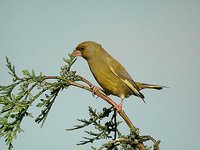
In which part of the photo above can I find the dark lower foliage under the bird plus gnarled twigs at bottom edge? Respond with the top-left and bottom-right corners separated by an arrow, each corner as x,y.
66,107 -> 159,150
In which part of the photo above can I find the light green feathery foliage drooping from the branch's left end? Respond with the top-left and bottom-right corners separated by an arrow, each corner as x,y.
0,57 -> 80,150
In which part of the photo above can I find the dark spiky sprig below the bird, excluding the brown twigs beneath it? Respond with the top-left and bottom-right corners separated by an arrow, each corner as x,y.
66,107 -> 121,145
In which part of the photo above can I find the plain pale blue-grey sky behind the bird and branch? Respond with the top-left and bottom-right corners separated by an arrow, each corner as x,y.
0,0 -> 200,150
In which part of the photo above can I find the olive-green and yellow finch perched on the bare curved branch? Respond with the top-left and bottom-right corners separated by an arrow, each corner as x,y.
71,41 -> 165,108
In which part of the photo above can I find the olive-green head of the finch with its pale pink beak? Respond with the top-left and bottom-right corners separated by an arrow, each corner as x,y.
71,41 -> 102,60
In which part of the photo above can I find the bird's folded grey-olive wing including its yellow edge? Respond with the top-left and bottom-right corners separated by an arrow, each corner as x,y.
109,59 -> 144,99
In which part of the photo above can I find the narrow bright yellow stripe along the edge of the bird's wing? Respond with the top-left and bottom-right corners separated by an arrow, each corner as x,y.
109,66 -> 144,99
